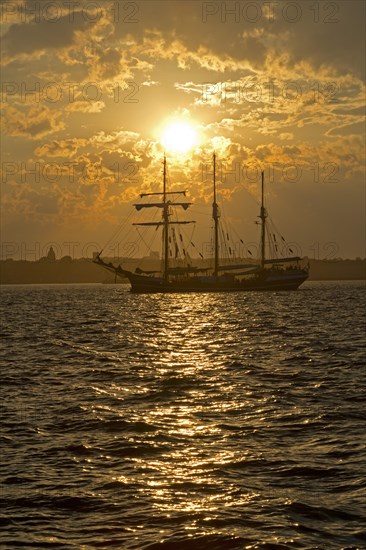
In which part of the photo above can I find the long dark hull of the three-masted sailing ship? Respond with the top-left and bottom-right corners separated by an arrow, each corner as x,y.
125,269 -> 308,294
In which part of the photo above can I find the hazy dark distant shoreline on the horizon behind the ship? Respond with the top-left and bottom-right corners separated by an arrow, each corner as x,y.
0,257 -> 366,285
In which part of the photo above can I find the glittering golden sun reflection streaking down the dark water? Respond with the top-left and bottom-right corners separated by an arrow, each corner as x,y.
91,294 -> 257,529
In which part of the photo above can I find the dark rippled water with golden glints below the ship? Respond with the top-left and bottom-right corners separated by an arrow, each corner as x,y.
0,282 -> 366,550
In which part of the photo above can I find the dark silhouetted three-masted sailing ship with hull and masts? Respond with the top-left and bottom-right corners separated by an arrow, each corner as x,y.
94,154 -> 309,293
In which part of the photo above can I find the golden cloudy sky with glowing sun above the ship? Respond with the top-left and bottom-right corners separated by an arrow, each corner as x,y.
0,0 -> 366,259
